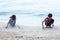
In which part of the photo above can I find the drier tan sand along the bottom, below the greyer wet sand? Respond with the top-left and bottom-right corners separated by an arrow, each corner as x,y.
0,31 -> 60,40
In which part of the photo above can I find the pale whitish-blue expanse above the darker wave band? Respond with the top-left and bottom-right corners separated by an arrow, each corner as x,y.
0,0 -> 60,12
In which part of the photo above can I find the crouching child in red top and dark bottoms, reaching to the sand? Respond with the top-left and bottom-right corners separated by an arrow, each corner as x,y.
42,13 -> 54,29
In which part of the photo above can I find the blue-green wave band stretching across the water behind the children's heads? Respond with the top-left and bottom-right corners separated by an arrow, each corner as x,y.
0,10 -> 60,17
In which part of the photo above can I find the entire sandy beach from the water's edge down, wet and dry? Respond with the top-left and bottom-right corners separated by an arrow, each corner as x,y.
0,24 -> 60,40
